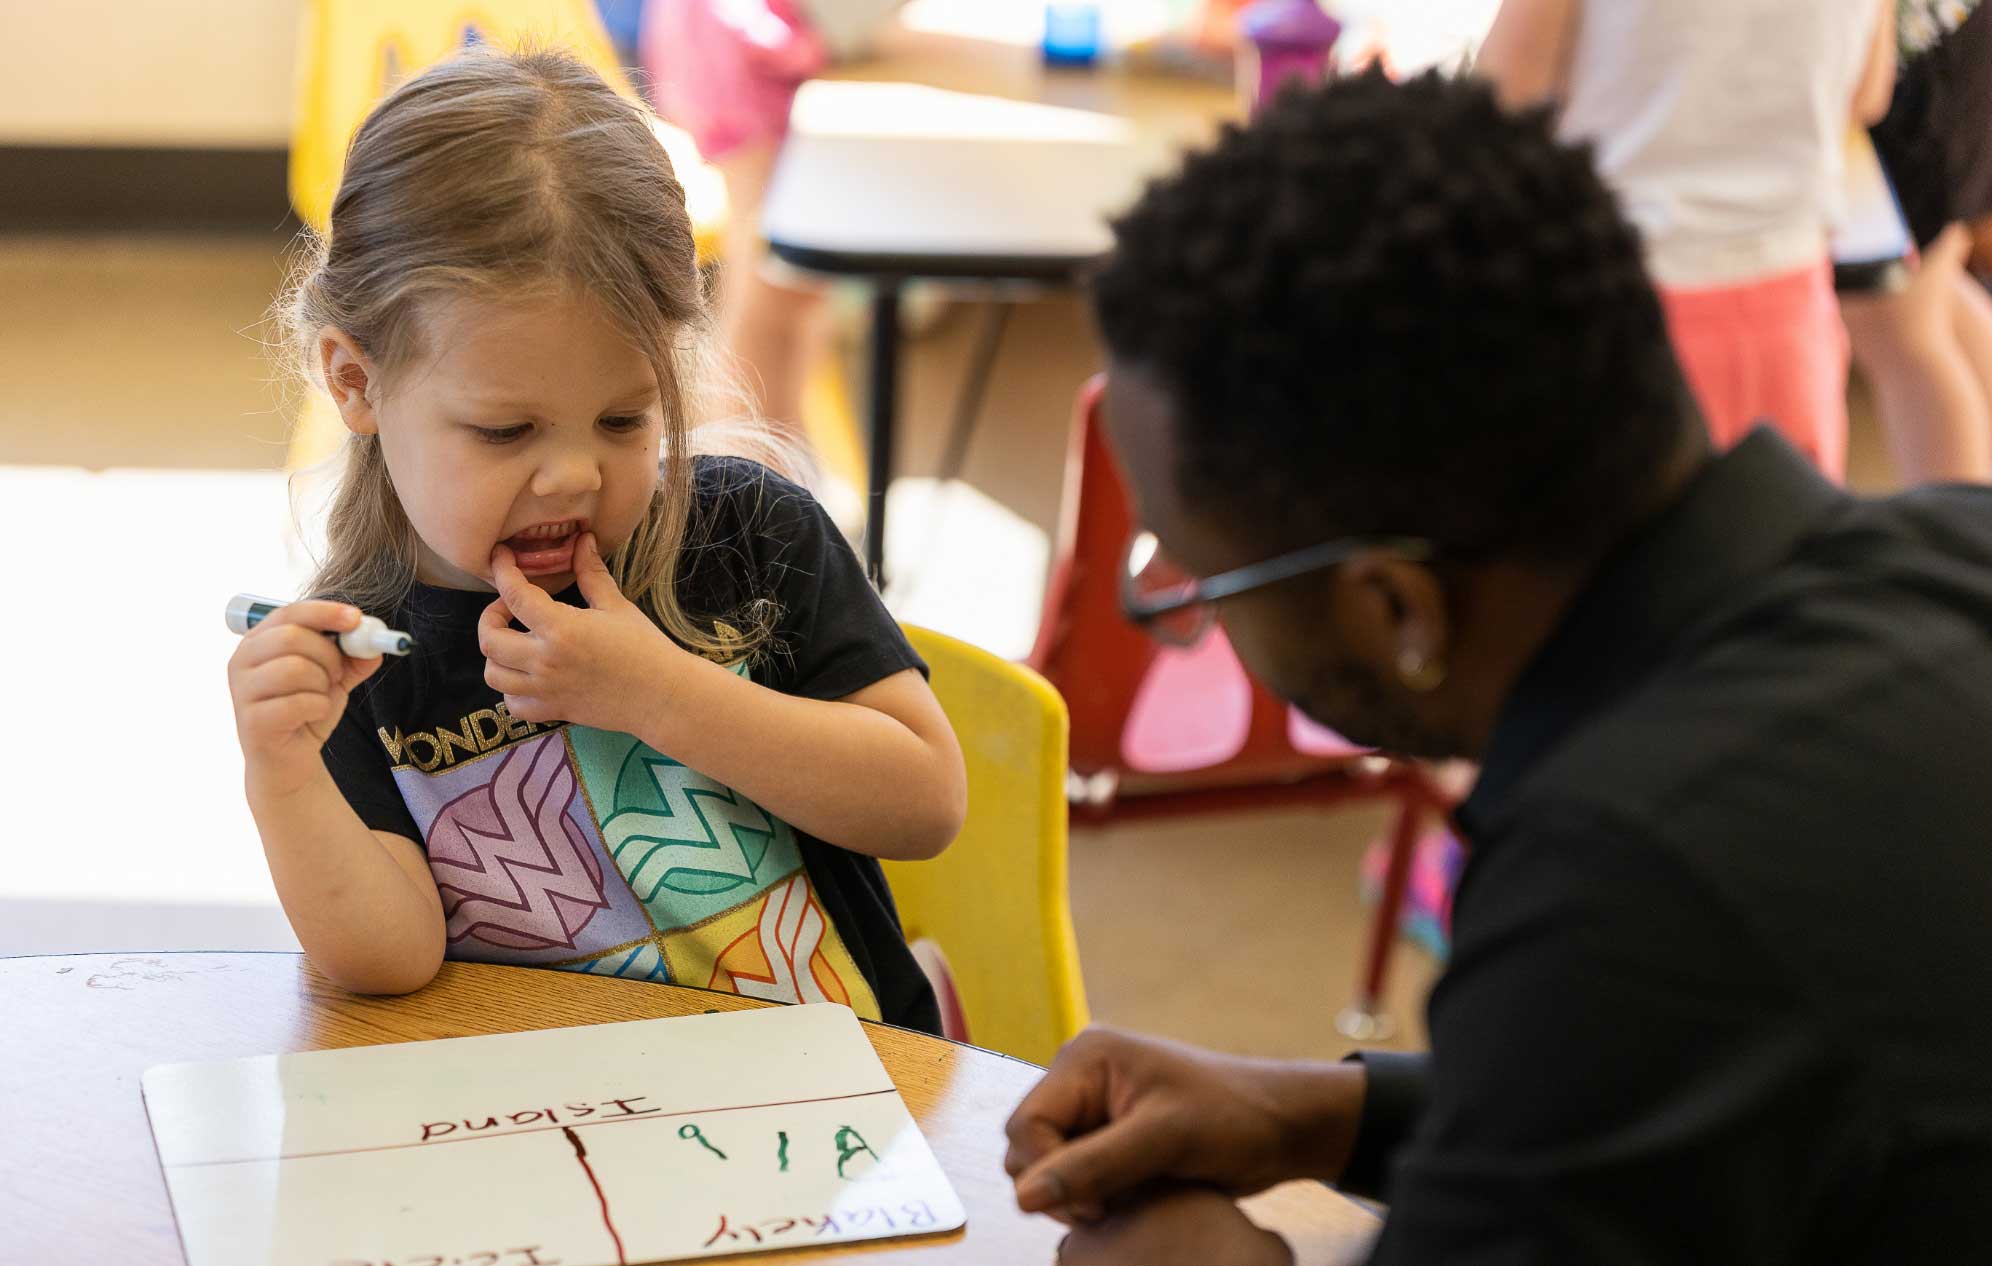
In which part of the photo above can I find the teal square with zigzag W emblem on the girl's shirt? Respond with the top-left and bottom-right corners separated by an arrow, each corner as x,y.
568,725 -> 803,932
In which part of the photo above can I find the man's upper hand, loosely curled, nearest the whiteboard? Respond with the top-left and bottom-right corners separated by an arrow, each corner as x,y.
1004,1029 -> 1365,1222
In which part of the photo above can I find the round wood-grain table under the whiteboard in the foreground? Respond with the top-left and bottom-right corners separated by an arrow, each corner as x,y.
0,953 -> 1372,1266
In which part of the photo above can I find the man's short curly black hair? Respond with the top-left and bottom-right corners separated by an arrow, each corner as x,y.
1094,74 -> 1701,557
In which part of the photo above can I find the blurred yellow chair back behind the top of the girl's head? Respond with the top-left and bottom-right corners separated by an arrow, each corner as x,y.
291,0 -> 629,233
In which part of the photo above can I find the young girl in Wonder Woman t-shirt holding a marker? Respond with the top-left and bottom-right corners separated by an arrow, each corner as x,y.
229,52 -> 966,1029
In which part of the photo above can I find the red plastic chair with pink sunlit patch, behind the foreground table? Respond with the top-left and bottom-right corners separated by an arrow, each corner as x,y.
1030,376 -> 1450,1039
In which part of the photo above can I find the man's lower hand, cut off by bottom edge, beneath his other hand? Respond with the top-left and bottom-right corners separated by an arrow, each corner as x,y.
1058,1186 -> 1293,1266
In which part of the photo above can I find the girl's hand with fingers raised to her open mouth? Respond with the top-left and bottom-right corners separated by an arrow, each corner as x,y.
478,531 -> 697,733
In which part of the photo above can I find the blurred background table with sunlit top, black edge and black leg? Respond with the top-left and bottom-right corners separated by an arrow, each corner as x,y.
761,19 -> 1235,581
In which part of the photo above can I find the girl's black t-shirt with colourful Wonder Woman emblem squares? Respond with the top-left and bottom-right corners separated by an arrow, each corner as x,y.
325,458 -> 940,1031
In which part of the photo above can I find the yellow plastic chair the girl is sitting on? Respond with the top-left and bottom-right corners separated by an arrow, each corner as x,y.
884,625 -> 1086,1063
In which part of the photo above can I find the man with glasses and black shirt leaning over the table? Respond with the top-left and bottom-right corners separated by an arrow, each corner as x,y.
1008,76 -> 1992,1266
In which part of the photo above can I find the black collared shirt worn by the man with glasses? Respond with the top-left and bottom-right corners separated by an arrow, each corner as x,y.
1345,430 -> 1992,1266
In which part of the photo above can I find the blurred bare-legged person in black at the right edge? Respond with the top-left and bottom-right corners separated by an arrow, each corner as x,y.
1841,0 -> 1992,484
